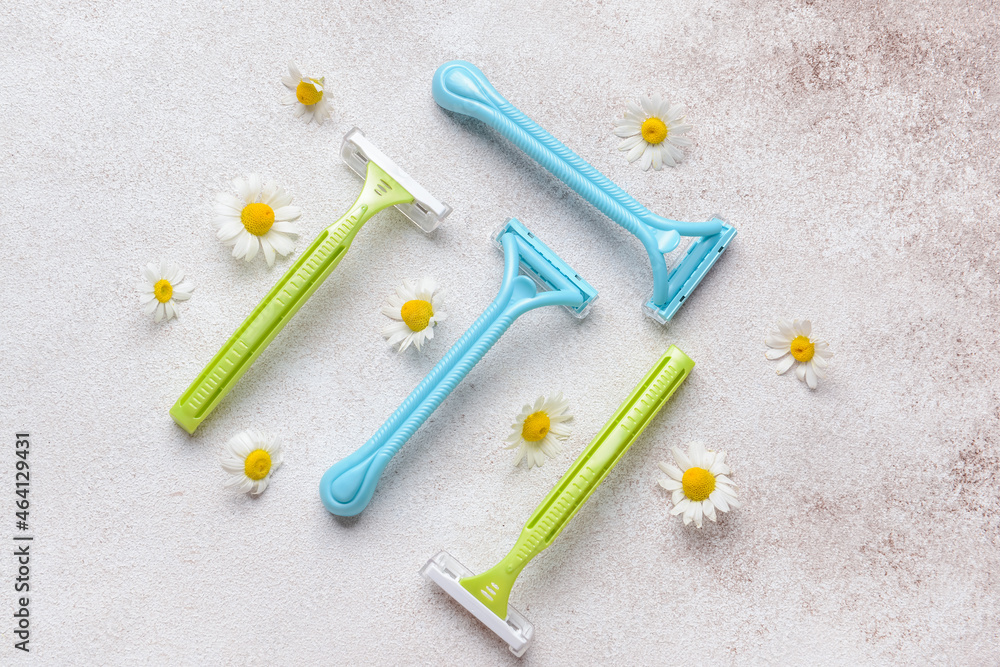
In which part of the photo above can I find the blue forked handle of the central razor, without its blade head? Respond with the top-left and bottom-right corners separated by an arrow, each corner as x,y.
319,232 -> 583,516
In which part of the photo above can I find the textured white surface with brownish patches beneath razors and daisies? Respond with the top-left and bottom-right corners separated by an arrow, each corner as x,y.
0,0 -> 1000,665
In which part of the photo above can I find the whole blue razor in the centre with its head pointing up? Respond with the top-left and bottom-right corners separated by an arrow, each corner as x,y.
319,218 -> 597,516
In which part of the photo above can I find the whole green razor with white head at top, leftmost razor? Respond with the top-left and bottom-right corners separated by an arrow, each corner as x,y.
170,128 -> 451,433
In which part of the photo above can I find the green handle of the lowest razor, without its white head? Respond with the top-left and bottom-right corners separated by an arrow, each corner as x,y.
459,345 -> 694,619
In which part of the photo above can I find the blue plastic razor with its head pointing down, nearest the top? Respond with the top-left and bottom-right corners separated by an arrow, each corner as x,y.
433,60 -> 736,324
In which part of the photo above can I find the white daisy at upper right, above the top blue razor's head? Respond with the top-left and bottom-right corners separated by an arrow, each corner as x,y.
615,95 -> 693,171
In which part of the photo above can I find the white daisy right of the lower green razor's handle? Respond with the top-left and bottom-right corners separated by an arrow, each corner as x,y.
658,442 -> 740,528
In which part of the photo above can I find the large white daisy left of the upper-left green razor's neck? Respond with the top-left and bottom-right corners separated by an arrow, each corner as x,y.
213,174 -> 302,266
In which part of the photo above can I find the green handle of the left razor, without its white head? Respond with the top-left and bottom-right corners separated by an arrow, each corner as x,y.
170,162 -> 413,434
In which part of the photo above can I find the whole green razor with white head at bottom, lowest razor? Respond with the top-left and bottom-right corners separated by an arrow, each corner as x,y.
420,345 -> 694,656
